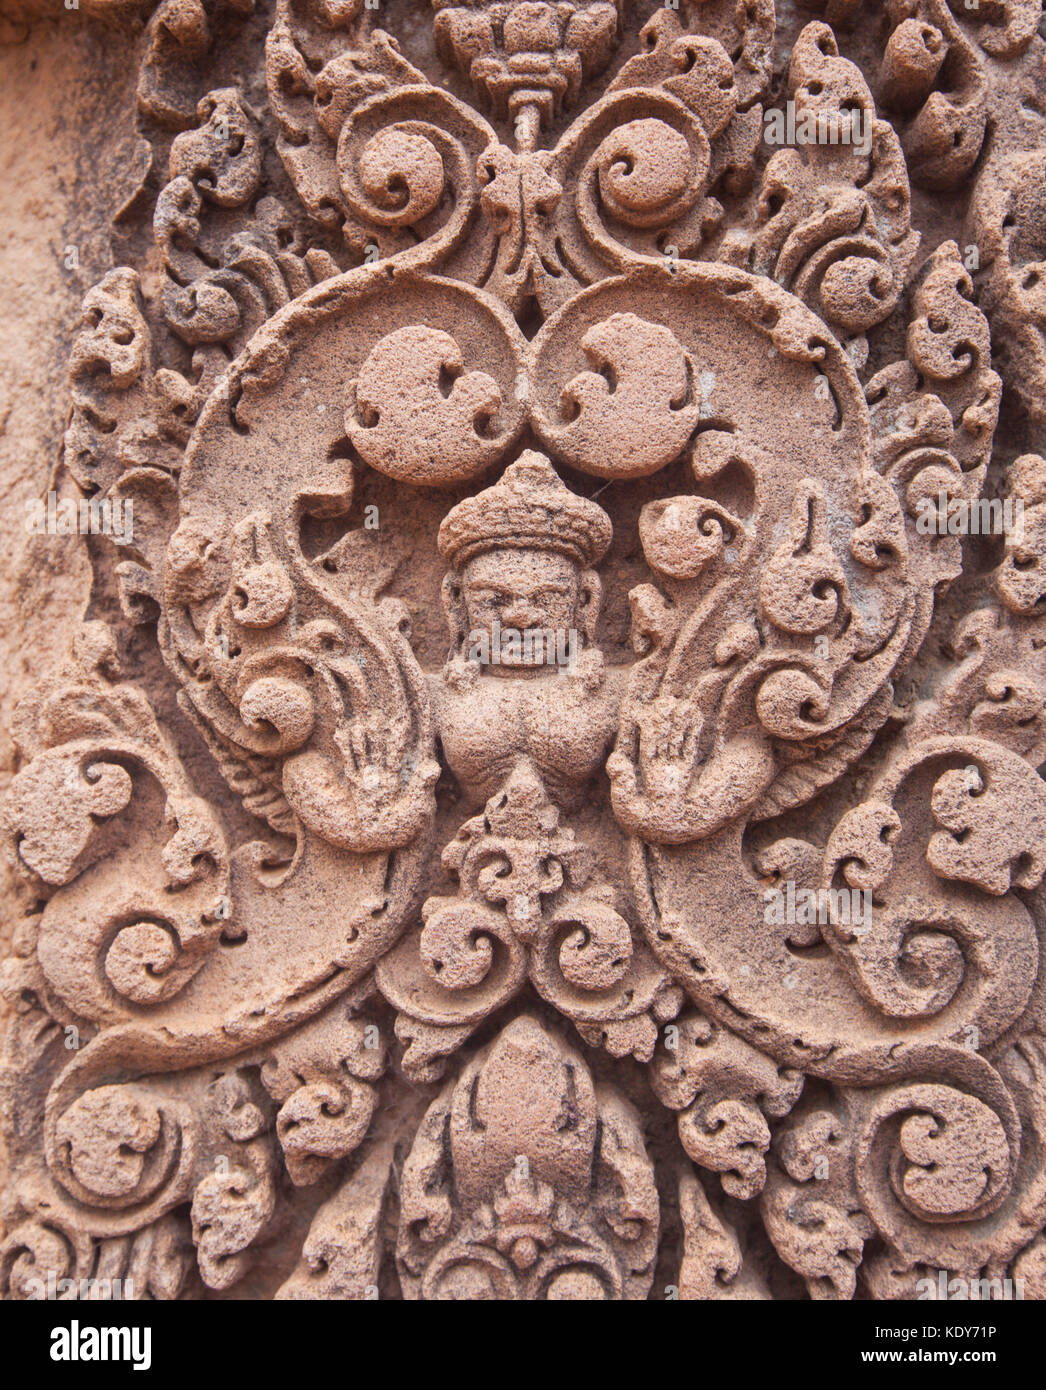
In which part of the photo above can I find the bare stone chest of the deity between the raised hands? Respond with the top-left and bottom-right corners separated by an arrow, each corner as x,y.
435,674 -> 618,805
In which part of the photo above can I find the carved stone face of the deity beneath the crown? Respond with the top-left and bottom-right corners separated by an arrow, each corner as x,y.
461,549 -> 582,667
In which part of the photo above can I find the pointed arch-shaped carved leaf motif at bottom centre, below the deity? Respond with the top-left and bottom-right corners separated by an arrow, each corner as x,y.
396,1015 -> 658,1300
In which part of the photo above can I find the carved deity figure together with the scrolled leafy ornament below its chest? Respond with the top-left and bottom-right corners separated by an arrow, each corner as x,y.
378,453 -> 682,1077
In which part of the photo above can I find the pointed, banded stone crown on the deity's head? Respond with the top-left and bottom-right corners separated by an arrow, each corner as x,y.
439,449 -> 614,569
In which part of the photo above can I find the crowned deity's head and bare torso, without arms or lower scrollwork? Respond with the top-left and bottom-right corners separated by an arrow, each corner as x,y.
432,452 -> 620,808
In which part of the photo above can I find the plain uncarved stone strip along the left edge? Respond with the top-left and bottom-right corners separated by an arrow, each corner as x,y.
0,6 -> 150,1212
